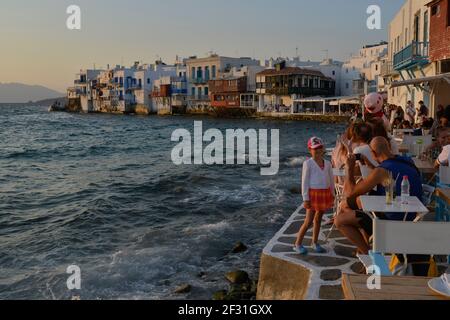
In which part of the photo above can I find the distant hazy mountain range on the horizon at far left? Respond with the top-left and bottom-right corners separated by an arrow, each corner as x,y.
0,83 -> 65,103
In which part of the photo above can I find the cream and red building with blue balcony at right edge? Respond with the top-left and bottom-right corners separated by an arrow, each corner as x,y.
383,0 -> 450,117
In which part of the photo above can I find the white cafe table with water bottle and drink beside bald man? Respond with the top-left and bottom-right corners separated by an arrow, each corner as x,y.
360,196 -> 429,220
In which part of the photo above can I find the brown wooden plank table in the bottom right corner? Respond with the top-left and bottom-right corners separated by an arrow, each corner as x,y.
342,274 -> 446,301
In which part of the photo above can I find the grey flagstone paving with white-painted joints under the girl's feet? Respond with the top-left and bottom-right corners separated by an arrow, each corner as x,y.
264,207 -> 364,300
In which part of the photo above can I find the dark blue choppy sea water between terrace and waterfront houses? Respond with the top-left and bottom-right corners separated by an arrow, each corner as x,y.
0,105 -> 344,299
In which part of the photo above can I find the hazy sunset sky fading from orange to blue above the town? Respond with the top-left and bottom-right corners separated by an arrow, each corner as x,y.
0,0 -> 404,92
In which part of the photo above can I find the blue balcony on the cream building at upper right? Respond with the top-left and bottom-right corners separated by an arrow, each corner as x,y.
394,41 -> 430,71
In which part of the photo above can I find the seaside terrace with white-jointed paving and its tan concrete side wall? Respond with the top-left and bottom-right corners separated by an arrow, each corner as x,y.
258,207 -> 364,300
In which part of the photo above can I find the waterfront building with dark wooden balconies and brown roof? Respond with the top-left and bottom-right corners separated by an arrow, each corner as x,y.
256,62 -> 335,113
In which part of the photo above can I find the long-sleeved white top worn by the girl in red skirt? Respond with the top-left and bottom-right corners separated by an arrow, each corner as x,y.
302,159 -> 334,201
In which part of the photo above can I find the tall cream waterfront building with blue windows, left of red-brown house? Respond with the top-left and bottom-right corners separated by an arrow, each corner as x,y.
186,54 -> 260,113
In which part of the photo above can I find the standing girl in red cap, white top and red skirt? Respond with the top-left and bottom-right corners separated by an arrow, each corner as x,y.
294,137 -> 334,255
